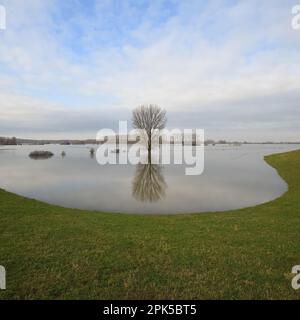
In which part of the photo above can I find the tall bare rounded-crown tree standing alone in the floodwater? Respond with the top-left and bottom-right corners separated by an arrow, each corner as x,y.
132,104 -> 167,162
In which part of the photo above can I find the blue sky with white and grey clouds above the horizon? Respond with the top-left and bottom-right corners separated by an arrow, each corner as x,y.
0,0 -> 300,141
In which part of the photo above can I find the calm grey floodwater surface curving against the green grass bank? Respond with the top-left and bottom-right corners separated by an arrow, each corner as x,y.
0,145 -> 299,214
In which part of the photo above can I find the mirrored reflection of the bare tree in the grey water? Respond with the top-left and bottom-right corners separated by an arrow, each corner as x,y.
132,163 -> 167,202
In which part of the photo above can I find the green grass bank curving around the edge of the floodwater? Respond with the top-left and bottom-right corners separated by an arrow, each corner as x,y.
0,151 -> 300,299
